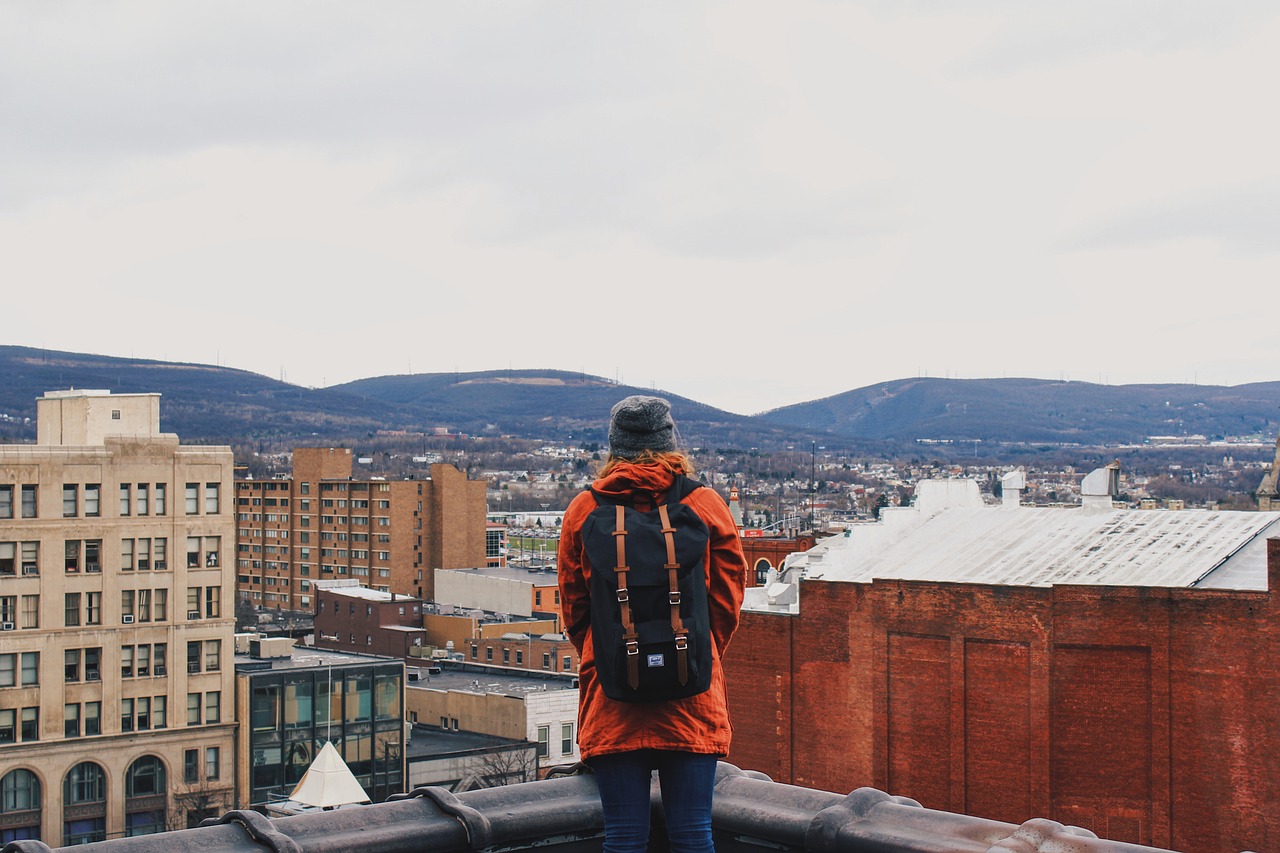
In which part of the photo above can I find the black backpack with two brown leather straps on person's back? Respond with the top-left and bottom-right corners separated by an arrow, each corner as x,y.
582,475 -> 712,702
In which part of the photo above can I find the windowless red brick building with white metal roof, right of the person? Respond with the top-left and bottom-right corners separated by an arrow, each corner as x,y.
726,471 -> 1280,853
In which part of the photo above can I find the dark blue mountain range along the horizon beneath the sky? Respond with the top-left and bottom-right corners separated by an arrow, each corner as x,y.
0,346 -> 1280,452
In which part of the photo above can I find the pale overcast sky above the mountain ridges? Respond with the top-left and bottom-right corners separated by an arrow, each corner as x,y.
0,0 -> 1280,414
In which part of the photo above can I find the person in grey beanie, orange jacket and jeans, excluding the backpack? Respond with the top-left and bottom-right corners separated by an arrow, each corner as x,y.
558,396 -> 746,853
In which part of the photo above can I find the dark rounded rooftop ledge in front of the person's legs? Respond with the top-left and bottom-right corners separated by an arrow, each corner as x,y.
0,762 -> 1213,853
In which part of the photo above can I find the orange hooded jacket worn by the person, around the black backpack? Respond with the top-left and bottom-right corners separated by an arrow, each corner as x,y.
558,462 -> 746,760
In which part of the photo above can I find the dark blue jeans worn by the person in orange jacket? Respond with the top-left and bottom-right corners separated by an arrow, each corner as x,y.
589,749 -> 717,853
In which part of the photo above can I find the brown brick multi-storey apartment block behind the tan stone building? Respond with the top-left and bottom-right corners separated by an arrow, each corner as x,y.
236,447 -> 486,613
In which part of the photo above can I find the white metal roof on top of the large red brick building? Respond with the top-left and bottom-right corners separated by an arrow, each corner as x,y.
787,481 -> 1280,589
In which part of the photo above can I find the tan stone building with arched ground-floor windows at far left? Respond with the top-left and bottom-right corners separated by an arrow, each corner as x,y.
0,391 -> 234,847
